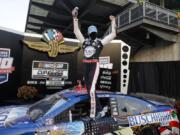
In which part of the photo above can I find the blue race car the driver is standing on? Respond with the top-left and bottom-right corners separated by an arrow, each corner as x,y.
0,89 -> 179,135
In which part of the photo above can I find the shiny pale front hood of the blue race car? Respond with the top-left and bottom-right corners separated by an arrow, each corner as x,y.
0,106 -> 28,127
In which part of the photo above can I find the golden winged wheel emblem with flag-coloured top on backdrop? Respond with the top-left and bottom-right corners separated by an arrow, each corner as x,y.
23,29 -> 79,57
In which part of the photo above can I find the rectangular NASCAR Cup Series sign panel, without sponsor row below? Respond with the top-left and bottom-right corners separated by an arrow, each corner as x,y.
32,61 -> 69,81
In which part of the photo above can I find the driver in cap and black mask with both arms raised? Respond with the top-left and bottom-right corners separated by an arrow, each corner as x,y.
72,7 -> 116,118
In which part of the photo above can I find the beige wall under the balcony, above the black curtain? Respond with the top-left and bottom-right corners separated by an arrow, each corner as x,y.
131,33 -> 180,62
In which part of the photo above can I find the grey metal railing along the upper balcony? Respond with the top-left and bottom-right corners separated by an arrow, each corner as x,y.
106,2 -> 178,34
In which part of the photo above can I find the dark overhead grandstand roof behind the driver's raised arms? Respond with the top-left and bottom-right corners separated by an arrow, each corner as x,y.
26,0 -> 129,37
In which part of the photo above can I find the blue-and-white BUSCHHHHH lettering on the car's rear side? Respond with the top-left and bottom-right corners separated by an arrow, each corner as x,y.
128,112 -> 173,127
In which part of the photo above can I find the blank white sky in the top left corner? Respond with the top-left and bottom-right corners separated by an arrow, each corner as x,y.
0,0 -> 29,32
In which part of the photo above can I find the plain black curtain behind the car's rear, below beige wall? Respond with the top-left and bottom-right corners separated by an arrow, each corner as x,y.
129,61 -> 180,98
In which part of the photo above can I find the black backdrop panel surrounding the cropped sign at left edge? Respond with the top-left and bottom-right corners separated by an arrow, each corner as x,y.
0,30 -> 23,99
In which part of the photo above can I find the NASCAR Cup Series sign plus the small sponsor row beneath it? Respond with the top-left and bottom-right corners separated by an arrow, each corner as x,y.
30,60 -> 69,89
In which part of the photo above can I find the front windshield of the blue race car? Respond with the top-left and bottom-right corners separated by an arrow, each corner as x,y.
28,93 -> 67,120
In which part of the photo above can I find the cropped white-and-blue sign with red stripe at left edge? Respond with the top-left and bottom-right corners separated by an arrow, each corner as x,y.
0,48 -> 15,84
